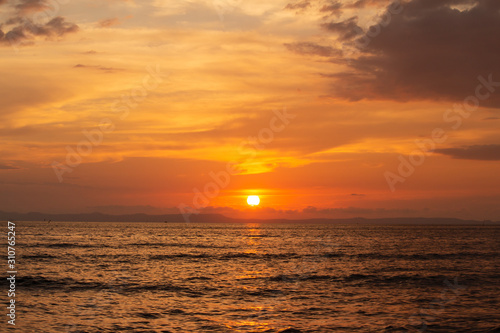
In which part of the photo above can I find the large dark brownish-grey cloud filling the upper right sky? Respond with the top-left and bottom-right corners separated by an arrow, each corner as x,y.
292,0 -> 500,106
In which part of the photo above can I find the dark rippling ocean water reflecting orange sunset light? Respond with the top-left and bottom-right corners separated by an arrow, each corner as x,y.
5,222 -> 500,333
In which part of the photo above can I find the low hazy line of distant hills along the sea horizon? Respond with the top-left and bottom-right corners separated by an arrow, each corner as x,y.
0,211 -> 500,225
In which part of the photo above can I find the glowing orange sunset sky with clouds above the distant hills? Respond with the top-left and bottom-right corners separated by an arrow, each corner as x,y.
0,0 -> 500,220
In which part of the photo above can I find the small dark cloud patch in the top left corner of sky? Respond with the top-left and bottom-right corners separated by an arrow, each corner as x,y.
0,0 -> 78,46
